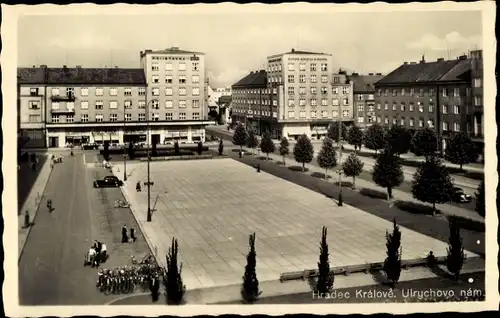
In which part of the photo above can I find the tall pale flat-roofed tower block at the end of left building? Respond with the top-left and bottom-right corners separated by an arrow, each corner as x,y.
140,47 -> 213,143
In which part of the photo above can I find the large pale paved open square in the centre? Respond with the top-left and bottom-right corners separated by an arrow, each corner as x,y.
113,159 -> 474,289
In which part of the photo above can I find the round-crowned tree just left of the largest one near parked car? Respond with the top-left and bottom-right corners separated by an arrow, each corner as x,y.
372,149 -> 404,199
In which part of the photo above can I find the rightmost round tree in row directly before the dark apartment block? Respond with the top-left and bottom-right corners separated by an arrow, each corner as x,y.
444,132 -> 479,171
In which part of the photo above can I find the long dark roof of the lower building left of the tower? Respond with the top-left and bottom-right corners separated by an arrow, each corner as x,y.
17,65 -> 146,85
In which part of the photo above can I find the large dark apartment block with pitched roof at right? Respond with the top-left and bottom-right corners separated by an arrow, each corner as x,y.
375,55 -> 472,151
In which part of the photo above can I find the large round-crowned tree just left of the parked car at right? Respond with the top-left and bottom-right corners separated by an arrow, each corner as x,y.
411,156 -> 453,215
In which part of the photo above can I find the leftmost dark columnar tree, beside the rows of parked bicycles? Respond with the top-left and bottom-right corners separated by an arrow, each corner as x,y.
163,238 -> 186,305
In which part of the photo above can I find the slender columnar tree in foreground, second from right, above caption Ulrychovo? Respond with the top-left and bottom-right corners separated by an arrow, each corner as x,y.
384,219 -> 402,288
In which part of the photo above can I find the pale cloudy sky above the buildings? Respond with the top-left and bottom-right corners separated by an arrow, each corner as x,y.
18,9 -> 482,86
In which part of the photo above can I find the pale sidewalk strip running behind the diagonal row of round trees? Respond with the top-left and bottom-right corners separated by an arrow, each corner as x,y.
230,147 -> 484,223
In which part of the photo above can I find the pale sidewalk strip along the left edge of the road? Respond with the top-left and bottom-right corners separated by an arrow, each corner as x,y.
17,158 -> 52,258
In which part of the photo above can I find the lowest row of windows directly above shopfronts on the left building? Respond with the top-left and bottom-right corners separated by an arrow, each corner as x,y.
48,113 -> 200,123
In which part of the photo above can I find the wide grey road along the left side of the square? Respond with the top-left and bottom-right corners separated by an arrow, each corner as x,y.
19,151 -> 149,305
